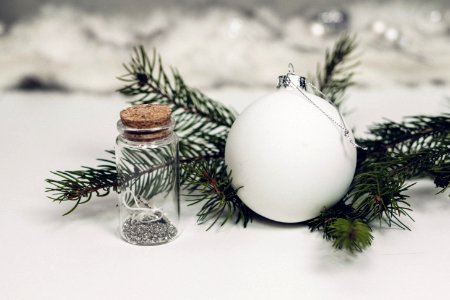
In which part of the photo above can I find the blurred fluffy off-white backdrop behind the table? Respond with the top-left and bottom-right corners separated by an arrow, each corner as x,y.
0,0 -> 450,93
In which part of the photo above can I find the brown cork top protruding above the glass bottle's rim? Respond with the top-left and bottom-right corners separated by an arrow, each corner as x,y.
120,104 -> 172,128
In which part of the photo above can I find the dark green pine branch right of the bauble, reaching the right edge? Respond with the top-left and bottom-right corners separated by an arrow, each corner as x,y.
308,114 -> 450,250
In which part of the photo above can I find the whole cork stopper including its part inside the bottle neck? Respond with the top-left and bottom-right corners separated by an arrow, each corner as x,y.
117,104 -> 175,142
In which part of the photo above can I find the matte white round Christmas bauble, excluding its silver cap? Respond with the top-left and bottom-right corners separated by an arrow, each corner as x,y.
225,87 -> 356,223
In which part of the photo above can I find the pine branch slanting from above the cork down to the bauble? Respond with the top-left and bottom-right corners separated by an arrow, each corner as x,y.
119,46 -> 236,157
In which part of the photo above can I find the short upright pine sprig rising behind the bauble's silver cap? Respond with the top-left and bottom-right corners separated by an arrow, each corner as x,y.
312,34 -> 358,107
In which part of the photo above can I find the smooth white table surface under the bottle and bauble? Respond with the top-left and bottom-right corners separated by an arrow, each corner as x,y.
0,88 -> 450,300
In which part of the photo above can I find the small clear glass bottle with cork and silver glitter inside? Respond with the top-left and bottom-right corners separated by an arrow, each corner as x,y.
116,104 -> 180,245
